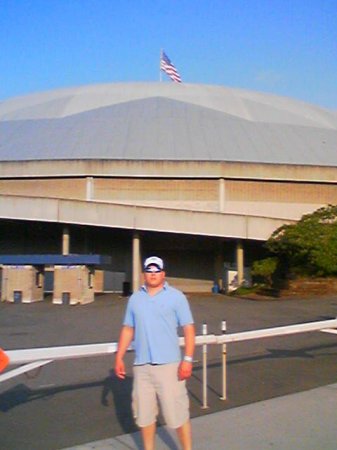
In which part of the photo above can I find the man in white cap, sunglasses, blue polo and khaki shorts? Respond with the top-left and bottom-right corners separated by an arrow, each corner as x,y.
115,256 -> 195,450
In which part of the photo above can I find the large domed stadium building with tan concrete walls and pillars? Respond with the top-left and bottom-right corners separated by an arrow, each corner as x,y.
0,83 -> 337,292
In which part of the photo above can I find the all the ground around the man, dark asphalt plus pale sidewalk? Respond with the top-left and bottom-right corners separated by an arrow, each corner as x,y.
0,294 -> 337,450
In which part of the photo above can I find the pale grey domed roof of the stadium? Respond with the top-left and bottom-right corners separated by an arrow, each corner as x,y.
0,83 -> 337,166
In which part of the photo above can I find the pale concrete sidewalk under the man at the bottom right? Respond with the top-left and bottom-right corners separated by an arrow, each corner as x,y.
64,384 -> 337,450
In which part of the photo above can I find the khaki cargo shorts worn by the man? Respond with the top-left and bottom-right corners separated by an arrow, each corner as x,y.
132,363 -> 189,428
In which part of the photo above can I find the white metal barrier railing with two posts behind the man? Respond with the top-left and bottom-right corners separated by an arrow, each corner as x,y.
0,318 -> 337,408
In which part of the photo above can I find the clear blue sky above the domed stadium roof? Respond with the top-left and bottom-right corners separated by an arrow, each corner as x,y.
0,0 -> 337,110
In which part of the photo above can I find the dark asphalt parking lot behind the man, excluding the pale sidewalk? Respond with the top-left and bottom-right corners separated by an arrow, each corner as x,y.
0,294 -> 337,450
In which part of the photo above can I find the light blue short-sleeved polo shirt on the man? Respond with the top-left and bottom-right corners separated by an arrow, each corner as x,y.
123,282 -> 193,365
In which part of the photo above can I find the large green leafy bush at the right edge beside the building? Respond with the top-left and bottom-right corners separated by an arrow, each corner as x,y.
266,205 -> 337,276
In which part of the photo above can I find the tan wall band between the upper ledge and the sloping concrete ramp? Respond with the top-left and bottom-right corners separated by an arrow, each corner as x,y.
0,177 -> 337,214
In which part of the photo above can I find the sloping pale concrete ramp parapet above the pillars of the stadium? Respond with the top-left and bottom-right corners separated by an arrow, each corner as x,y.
0,195 -> 295,241
